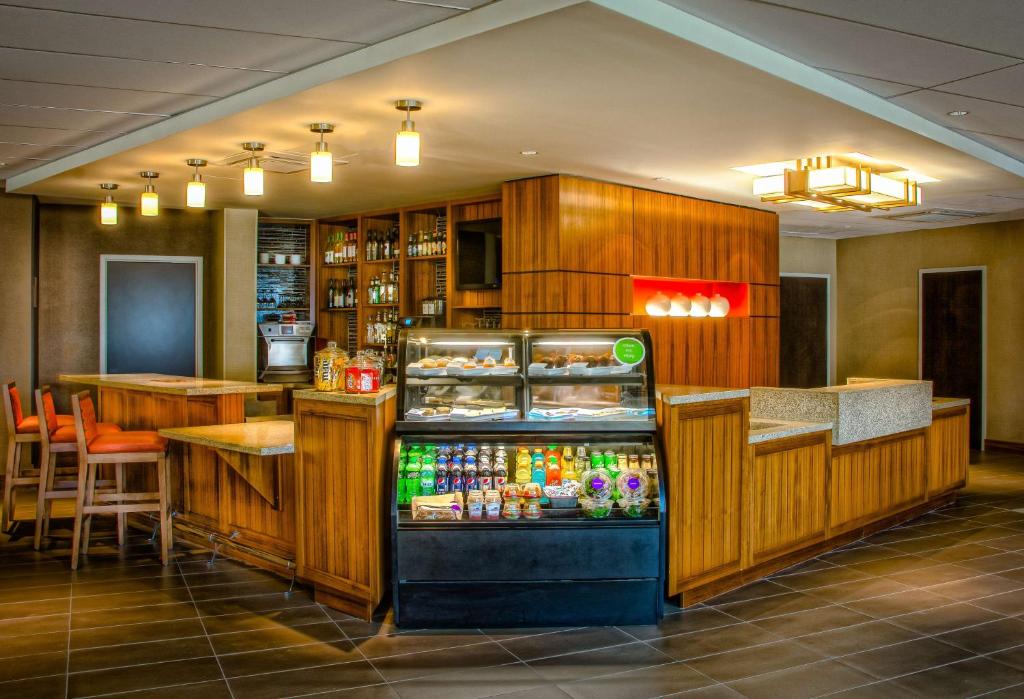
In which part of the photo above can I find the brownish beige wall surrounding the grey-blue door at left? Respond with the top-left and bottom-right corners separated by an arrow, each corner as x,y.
38,205 -> 216,411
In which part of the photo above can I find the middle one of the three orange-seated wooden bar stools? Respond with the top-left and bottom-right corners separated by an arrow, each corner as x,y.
33,386 -> 124,551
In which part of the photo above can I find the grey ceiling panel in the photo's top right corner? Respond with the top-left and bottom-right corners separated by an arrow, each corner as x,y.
749,0 -> 1024,58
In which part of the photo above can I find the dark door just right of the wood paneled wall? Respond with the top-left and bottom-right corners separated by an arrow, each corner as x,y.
779,274 -> 829,388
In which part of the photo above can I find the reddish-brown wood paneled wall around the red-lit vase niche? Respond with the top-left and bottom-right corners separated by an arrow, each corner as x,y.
502,175 -> 779,387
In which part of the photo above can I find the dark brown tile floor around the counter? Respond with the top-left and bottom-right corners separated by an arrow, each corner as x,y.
0,454 -> 1024,699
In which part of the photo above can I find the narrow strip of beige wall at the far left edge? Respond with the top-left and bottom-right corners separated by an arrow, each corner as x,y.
0,193 -> 35,454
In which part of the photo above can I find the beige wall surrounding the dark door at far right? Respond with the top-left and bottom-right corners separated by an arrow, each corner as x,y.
837,221 -> 1024,442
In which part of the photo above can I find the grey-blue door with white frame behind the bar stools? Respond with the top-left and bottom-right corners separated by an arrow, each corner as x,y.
99,255 -> 203,377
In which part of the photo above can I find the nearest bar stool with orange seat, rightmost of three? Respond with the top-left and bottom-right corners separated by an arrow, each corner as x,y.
71,391 -> 174,570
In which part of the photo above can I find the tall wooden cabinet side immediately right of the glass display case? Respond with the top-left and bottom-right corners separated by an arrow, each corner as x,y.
658,398 -> 750,595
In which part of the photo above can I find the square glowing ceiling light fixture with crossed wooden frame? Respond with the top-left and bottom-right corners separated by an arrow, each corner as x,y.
733,152 -> 938,212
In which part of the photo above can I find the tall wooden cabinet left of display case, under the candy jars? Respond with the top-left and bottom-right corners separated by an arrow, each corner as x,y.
295,392 -> 395,619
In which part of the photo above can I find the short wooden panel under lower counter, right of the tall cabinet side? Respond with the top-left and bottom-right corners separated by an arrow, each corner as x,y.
744,432 -> 829,565
